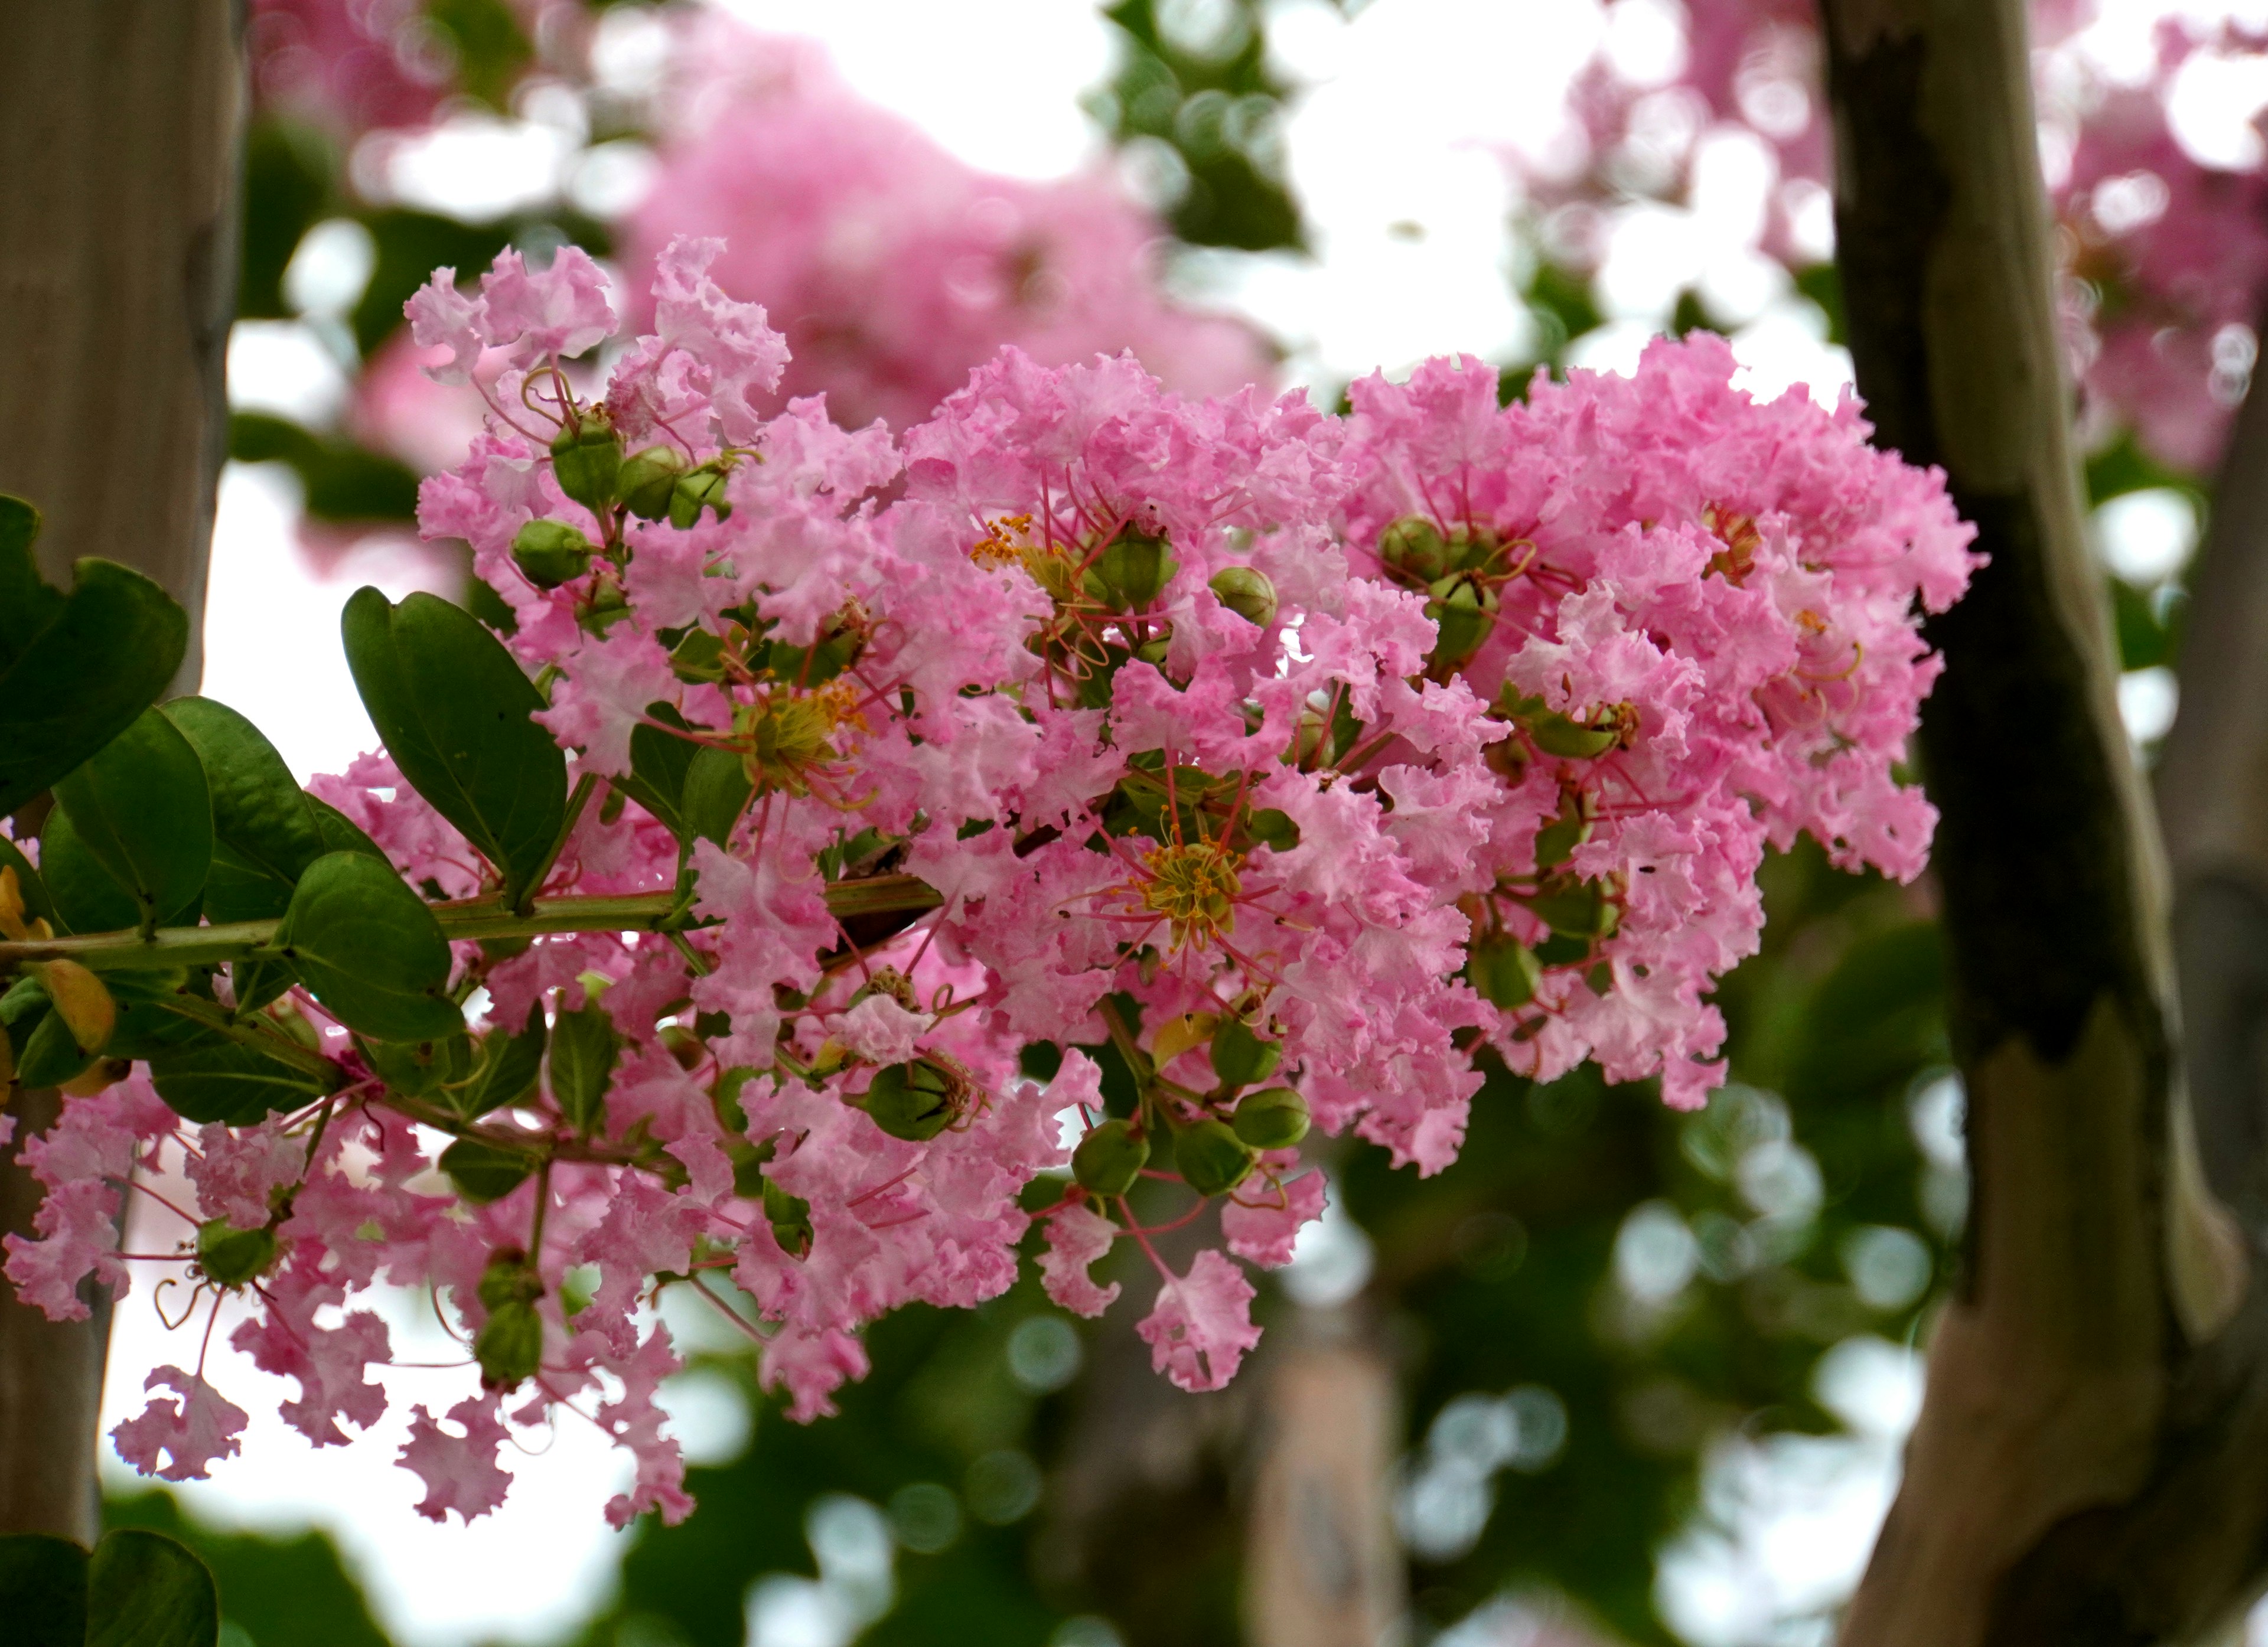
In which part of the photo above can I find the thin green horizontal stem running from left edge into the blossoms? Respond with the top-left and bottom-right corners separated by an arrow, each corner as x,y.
0,876 -> 943,973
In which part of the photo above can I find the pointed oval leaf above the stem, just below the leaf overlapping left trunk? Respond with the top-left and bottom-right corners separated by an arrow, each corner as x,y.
54,710 -> 213,925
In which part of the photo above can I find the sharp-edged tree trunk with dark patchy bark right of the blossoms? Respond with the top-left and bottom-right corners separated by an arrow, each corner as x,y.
1823,0 -> 2268,1647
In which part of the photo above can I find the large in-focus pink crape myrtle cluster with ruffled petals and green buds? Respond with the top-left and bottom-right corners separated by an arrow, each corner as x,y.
0,240 -> 1971,1525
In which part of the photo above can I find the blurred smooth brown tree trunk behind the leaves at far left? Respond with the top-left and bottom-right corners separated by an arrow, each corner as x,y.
0,0 -> 245,1545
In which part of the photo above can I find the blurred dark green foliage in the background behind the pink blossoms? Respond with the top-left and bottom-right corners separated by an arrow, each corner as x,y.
128,0 -> 2204,1647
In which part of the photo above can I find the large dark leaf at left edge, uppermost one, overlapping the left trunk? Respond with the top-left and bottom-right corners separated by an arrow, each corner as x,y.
0,497 -> 188,812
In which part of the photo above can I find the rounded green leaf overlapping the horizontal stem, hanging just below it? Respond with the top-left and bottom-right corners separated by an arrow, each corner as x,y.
276,853 -> 465,1041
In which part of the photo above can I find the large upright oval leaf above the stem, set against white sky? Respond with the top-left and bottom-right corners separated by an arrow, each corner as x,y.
340,588 -> 567,903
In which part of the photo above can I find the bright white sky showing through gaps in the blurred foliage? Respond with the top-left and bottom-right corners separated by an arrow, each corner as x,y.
172,0 -> 2268,1647
